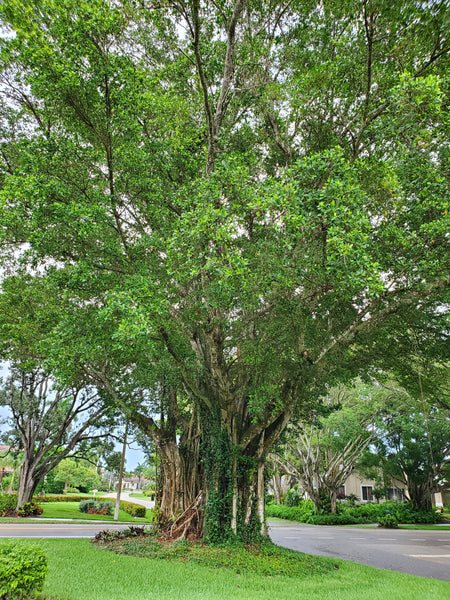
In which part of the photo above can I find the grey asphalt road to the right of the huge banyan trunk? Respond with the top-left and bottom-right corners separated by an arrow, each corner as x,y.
269,522 -> 450,581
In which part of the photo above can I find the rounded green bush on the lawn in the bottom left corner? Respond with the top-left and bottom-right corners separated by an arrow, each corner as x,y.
0,543 -> 47,600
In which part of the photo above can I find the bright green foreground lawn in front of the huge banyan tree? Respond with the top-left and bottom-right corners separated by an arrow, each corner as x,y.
6,539 -> 450,600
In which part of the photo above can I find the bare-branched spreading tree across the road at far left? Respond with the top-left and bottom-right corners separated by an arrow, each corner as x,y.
0,367 -> 116,505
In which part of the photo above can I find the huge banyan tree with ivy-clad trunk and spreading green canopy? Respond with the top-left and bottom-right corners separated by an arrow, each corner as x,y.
1,0 -> 450,539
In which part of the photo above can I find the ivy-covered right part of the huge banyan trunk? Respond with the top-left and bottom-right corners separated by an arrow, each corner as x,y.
201,398 -> 289,543
